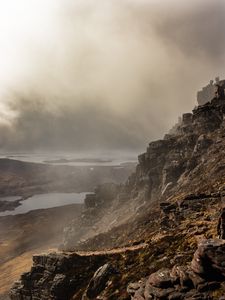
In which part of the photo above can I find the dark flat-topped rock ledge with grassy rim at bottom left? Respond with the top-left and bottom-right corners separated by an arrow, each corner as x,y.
10,245 -> 146,300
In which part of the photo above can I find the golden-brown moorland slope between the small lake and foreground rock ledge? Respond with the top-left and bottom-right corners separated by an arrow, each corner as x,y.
0,204 -> 83,299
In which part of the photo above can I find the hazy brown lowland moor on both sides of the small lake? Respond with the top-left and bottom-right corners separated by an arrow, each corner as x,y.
0,159 -> 134,300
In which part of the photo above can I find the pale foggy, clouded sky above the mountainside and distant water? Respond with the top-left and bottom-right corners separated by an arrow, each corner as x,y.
0,0 -> 225,151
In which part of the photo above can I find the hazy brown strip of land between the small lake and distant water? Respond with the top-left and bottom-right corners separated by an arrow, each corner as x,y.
0,159 -> 134,211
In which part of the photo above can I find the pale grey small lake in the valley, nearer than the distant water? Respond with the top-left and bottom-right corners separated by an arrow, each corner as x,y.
0,193 -> 87,217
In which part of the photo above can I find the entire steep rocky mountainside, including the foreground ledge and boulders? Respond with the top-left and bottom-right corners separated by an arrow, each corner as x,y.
11,97 -> 225,300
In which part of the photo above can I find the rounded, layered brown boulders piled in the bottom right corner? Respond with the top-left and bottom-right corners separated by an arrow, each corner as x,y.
127,239 -> 225,300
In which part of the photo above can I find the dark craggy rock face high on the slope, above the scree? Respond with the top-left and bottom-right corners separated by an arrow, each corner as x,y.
131,100 -> 225,199
